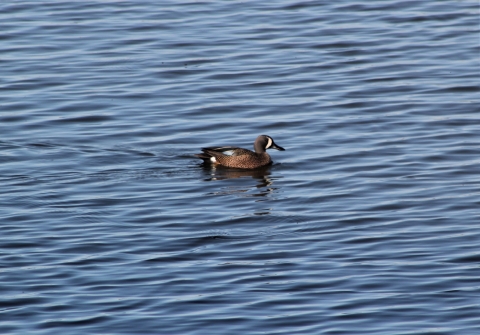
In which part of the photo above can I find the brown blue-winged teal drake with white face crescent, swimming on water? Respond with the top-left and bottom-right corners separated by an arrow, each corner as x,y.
195,135 -> 285,169
